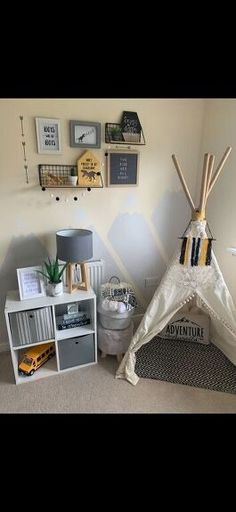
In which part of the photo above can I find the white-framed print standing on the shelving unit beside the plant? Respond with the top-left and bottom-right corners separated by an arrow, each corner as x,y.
17,266 -> 46,300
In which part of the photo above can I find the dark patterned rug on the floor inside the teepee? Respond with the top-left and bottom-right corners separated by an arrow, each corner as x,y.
135,336 -> 236,393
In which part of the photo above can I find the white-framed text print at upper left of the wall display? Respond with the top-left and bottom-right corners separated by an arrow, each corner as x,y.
35,117 -> 61,155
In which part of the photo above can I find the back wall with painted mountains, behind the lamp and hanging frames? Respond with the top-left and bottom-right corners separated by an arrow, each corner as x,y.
0,99 -> 205,344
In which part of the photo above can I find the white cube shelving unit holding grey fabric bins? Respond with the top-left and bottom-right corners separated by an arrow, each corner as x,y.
5,289 -> 97,384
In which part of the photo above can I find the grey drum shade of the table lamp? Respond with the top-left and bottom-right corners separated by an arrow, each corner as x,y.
56,229 -> 93,263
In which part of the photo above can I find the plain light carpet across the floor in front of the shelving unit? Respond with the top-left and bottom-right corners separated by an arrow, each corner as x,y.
0,352 -> 236,414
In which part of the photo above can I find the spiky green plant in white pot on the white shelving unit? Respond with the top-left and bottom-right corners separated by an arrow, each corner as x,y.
38,257 -> 68,297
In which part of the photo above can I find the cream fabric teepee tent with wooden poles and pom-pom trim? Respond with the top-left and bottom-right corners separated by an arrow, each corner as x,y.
116,147 -> 236,384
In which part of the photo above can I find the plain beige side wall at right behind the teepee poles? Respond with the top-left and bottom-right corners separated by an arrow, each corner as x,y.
202,99 -> 236,303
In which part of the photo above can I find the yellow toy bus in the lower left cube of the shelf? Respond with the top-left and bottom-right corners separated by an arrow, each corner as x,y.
18,343 -> 55,375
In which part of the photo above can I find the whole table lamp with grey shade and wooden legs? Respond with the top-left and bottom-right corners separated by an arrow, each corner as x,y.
56,229 -> 93,293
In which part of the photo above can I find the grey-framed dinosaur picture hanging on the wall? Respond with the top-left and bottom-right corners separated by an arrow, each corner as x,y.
70,121 -> 101,148
